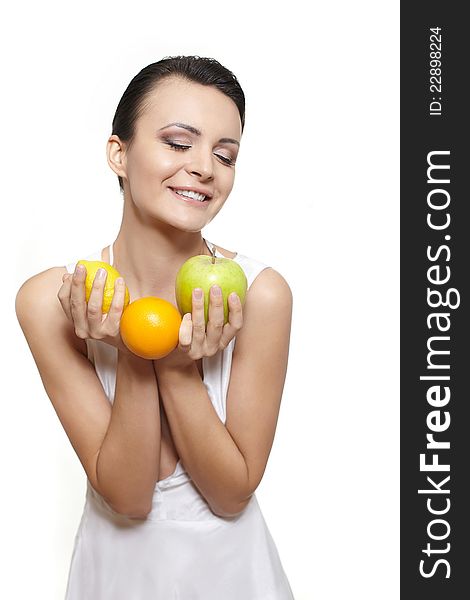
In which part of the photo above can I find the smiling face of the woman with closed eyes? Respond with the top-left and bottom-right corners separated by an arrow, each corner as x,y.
112,77 -> 241,232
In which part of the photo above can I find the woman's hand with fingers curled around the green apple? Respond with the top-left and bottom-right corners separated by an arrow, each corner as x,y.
154,285 -> 243,369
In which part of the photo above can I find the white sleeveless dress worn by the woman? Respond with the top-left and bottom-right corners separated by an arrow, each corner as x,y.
65,241 -> 293,600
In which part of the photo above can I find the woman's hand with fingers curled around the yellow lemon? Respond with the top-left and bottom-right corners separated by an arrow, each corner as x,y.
57,265 -> 130,354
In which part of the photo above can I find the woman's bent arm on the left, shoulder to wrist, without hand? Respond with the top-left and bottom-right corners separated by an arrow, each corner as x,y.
16,268 -> 160,518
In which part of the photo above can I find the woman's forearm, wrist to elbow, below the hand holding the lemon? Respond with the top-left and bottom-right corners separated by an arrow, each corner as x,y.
96,351 -> 160,517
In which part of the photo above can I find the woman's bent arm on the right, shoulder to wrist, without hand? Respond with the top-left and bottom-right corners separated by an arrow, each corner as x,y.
154,268 -> 292,517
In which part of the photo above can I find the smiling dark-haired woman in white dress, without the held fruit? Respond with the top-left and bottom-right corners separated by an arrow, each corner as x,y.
16,57 -> 292,600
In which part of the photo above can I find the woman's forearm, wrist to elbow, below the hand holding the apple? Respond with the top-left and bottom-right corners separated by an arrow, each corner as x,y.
154,361 -> 249,517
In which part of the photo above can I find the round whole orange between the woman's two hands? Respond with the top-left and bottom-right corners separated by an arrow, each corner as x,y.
121,296 -> 181,360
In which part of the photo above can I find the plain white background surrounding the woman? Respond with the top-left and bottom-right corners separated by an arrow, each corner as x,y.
0,0 -> 399,600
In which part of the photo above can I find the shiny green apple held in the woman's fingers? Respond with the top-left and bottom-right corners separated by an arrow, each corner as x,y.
175,248 -> 248,324
